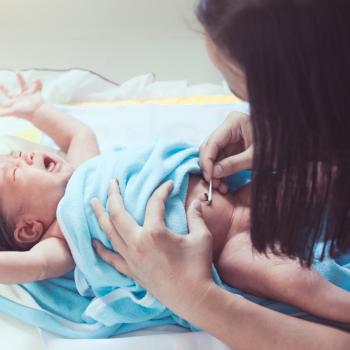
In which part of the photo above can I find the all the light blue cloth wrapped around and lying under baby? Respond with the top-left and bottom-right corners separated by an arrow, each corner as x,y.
0,142 -> 350,338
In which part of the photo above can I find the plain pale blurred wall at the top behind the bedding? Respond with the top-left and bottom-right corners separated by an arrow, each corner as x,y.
0,0 -> 222,83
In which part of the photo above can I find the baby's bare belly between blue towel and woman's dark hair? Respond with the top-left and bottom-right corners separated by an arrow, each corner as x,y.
186,175 -> 234,259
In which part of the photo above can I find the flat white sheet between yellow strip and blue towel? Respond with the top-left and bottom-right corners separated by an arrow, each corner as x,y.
43,104 -> 245,150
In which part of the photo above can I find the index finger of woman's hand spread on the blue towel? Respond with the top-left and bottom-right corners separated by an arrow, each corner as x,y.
144,181 -> 174,230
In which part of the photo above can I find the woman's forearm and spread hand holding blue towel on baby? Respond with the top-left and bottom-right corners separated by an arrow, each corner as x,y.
92,182 -> 350,350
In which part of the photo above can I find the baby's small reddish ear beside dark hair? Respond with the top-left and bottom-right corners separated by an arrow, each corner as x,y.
14,218 -> 44,248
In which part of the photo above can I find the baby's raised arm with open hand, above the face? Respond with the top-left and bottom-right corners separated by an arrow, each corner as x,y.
0,74 -> 99,166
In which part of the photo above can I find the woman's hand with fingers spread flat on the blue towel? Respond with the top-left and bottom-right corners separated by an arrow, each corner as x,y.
92,181 -> 214,315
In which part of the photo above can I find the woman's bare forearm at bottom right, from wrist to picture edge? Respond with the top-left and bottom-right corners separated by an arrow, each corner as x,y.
179,283 -> 350,350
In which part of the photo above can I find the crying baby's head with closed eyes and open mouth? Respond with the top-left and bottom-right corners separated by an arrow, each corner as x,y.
0,151 -> 73,250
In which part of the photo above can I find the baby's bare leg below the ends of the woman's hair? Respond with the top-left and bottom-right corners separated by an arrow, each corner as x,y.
217,233 -> 350,322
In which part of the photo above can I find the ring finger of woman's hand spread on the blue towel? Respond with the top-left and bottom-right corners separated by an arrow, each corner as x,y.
91,198 -> 127,254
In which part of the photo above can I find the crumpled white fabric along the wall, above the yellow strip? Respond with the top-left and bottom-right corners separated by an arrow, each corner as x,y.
0,69 -> 231,104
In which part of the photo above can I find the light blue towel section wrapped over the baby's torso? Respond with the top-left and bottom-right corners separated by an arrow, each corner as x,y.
57,142 -> 199,326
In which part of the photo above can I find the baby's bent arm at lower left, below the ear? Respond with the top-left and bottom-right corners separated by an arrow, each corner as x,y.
0,237 -> 74,284
